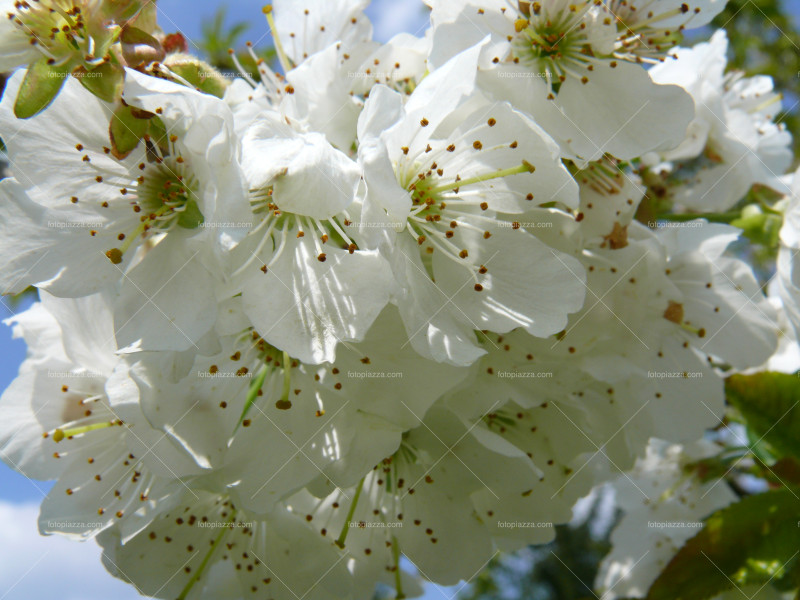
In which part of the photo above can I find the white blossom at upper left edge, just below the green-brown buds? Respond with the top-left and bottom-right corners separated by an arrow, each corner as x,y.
0,71 -> 249,350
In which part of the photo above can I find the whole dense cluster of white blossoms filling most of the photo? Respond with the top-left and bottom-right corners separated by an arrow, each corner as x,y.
0,0 -> 800,599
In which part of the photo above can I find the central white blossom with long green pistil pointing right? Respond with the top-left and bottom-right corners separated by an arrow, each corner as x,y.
359,45 -> 584,364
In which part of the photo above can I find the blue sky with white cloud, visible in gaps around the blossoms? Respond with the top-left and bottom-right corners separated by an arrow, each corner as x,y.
0,0 -> 800,600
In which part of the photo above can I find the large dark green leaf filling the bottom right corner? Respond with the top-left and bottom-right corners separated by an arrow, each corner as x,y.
647,489 -> 800,600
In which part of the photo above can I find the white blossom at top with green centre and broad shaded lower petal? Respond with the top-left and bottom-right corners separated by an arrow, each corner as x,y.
429,0 -> 691,161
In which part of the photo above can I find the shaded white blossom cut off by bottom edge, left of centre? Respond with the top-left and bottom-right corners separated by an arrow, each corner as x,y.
98,491 -> 352,600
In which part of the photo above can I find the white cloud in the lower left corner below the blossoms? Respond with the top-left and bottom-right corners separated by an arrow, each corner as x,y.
0,501 -> 141,600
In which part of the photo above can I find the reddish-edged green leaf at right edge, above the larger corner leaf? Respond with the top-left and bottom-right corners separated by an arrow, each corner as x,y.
726,373 -> 800,457
